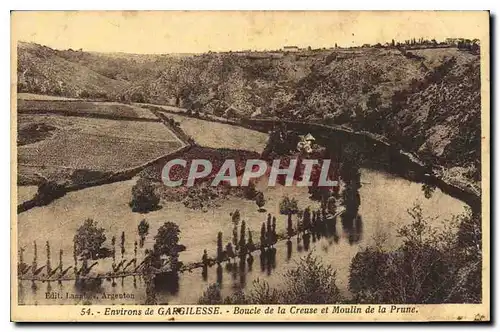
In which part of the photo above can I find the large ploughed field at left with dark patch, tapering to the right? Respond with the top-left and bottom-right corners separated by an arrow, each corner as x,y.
18,114 -> 183,183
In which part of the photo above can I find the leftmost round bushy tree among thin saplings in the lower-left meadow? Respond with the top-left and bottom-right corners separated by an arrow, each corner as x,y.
73,219 -> 106,259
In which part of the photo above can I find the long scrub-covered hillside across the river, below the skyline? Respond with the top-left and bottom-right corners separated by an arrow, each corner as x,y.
19,44 -> 480,180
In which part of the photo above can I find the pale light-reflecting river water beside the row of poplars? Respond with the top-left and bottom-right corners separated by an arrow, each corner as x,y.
19,169 -> 465,304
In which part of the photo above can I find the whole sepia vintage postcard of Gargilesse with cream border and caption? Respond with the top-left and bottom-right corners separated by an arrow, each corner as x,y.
11,11 -> 491,322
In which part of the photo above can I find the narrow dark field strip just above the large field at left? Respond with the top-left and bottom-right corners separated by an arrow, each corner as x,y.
17,99 -> 156,120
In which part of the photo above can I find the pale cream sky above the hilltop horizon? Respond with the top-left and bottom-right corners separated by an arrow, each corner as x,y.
11,11 -> 488,54
